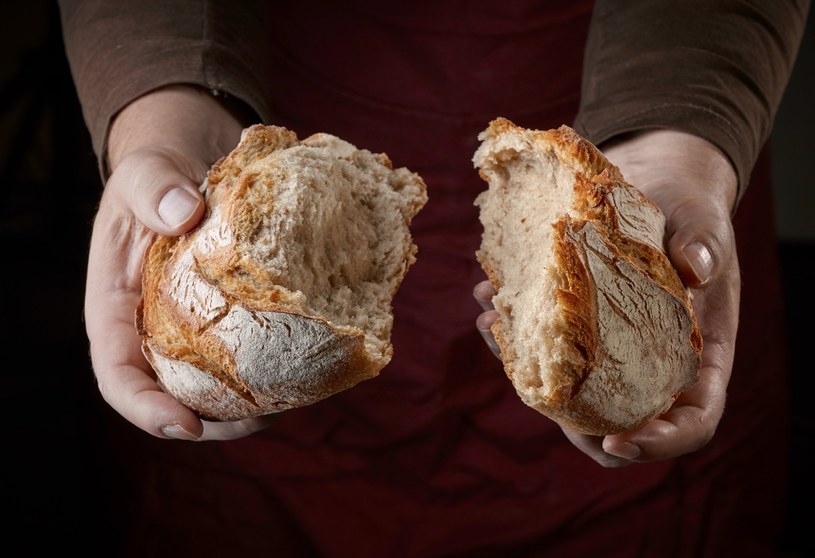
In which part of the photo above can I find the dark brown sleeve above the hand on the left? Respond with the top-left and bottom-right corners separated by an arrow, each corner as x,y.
59,0 -> 273,174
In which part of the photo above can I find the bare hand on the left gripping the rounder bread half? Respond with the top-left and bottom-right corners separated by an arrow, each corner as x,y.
85,87 -> 274,440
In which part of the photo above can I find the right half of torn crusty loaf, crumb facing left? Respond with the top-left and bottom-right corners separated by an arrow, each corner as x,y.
473,118 -> 702,435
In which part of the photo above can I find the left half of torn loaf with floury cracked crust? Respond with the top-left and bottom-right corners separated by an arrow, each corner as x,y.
136,125 -> 427,421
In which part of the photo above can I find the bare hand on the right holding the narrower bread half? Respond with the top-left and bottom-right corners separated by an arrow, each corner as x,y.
474,130 -> 740,467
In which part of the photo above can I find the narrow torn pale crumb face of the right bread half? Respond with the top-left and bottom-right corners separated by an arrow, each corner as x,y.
477,150 -> 575,394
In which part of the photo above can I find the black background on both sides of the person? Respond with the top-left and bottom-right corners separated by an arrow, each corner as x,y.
0,0 -> 815,557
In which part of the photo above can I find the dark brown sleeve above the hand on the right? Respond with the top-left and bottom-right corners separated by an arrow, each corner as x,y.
575,0 -> 809,199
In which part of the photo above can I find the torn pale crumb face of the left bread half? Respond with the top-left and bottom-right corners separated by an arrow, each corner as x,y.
230,135 -> 424,364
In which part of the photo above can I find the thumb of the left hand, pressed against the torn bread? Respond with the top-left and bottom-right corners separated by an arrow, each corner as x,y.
108,149 -> 205,236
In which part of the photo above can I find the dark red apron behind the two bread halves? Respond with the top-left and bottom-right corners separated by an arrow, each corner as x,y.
110,0 -> 784,558
